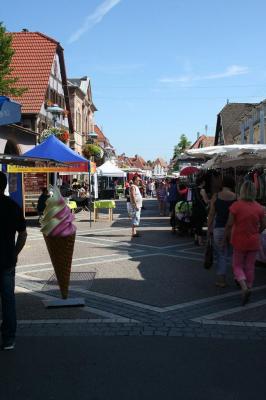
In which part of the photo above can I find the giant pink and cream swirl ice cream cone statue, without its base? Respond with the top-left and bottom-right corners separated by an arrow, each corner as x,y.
41,187 -> 76,299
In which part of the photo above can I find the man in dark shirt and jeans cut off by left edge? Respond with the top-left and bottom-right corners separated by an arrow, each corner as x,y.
0,172 -> 27,350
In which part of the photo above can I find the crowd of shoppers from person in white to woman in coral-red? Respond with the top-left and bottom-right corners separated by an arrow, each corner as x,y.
126,172 -> 266,305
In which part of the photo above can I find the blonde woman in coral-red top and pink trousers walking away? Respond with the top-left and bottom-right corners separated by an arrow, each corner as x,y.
225,181 -> 266,306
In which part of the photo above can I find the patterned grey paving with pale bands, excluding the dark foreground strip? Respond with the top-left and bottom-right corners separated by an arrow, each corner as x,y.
13,200 -> 266,340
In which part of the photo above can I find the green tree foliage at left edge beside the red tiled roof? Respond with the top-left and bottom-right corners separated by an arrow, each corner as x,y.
0,22 -> 27,97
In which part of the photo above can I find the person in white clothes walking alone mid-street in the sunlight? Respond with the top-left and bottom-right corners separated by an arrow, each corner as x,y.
130,175 -> 142,237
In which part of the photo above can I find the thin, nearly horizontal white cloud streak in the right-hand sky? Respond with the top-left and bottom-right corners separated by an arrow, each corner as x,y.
160,65 -> 249,83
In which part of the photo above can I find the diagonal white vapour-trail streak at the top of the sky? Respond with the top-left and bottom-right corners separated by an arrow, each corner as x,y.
68,0 -> 121,43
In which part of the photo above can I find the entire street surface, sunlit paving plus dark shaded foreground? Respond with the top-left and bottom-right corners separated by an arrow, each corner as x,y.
0,200 -> 266,400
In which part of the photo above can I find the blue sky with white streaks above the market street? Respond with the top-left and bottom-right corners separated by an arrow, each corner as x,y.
3,0 -> 266,160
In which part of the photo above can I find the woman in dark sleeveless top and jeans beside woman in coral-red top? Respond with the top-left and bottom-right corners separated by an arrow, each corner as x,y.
208,176 -> 236,288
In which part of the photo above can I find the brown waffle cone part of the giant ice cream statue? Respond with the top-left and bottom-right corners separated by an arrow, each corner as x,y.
43,234 -> 76,299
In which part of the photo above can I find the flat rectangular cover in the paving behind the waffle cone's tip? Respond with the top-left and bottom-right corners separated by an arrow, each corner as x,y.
42,272 -> 96,292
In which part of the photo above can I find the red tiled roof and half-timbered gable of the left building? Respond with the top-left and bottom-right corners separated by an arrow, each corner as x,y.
8,31 -> 73,133
